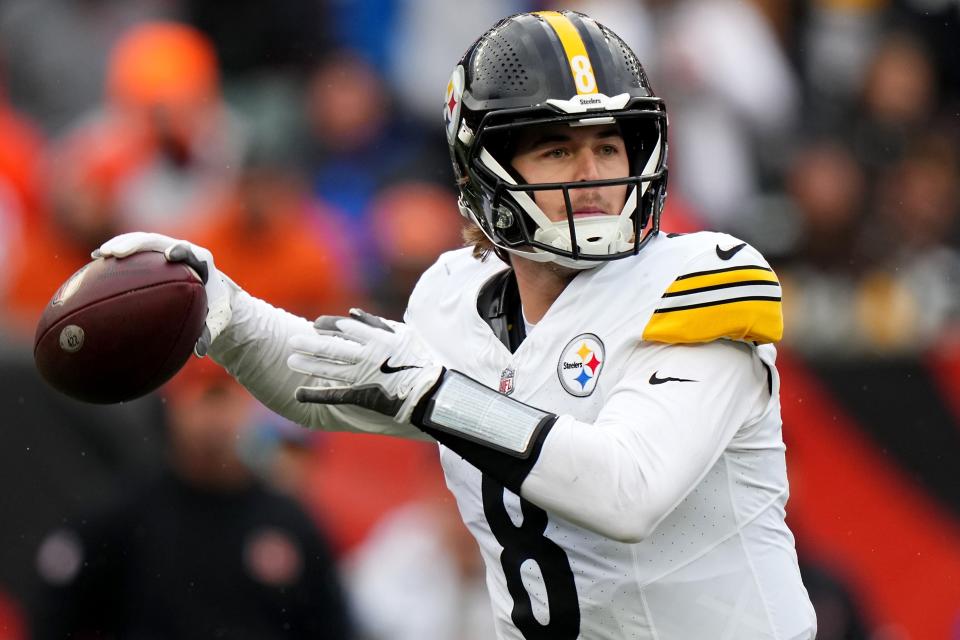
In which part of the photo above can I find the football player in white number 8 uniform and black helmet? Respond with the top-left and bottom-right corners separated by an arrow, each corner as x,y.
95,11 -> 816,640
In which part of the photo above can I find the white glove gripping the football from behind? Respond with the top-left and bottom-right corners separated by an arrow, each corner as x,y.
90,231 -> 236,358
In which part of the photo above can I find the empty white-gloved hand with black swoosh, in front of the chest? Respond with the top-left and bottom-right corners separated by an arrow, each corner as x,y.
287,309 -> 444,423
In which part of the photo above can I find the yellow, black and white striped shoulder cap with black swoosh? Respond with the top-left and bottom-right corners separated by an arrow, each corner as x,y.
643,234 -> 783,344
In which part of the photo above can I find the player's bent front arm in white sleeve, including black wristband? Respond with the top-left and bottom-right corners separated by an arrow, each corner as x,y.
414,343 -> 770,542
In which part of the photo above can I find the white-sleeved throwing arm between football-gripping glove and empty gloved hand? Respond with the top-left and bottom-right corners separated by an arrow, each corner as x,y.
210,291 -> 424,439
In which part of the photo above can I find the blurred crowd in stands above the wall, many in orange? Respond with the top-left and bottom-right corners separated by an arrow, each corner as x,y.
0,0 -> 960,358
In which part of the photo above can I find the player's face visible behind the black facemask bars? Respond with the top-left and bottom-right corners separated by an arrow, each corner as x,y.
511,124 -> 630,222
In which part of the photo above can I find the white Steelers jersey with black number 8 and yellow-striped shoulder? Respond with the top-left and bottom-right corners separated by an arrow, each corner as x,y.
406,233 -> 815,640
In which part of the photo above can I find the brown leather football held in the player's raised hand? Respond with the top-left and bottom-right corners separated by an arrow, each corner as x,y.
33,251 -> 207,404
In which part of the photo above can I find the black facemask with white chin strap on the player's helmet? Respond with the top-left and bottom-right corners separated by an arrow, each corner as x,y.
467,104 -> 666,269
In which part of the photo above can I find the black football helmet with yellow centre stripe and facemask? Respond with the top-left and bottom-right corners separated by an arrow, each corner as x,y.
443,11 -> 667,269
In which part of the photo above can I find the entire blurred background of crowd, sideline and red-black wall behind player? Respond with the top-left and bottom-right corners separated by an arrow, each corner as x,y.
0,0 -> 960,640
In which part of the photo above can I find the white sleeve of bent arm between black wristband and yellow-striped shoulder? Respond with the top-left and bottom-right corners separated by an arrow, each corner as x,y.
521,340 -> 772,542
